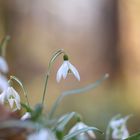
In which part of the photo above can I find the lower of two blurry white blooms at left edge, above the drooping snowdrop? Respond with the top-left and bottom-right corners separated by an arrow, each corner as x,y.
0,75 -> 9,92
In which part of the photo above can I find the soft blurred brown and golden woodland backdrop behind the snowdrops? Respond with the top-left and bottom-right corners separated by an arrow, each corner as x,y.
0,0 -> 140,138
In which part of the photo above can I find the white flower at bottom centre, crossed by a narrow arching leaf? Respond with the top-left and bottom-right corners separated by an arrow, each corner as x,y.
69,122 -> 96,140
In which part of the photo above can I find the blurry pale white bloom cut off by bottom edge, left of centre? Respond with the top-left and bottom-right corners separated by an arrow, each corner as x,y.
27,129 -> 56,140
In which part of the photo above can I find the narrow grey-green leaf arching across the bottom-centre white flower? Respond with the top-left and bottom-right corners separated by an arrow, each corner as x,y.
64,127 -> 103,140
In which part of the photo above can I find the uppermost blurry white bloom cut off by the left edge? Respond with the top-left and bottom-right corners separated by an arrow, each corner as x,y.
0,56 -> 8,73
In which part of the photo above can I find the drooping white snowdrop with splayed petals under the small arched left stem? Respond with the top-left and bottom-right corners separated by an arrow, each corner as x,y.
0,87 -> 21,111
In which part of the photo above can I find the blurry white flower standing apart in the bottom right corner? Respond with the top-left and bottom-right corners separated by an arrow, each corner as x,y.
110,116 -> 130,140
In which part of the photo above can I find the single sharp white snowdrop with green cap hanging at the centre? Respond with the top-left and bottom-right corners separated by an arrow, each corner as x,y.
56,55 -> 80,82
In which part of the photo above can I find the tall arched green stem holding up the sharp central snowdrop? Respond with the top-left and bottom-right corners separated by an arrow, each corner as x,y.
42,49 -> 65,106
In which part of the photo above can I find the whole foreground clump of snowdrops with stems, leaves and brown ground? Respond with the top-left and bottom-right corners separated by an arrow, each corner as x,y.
0,37 -> 137,140
